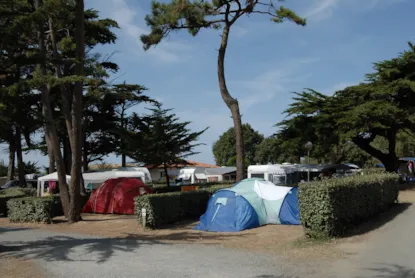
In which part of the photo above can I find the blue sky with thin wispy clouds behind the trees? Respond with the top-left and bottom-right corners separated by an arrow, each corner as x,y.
0,0 -> 415,166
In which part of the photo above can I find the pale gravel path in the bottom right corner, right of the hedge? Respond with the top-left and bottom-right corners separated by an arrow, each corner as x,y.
333,204 -> 415,278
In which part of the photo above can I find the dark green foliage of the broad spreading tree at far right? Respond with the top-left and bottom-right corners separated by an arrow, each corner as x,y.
278,44 -> 415,171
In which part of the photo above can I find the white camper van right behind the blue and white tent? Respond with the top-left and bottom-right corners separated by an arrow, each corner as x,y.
248,163 -> 300,185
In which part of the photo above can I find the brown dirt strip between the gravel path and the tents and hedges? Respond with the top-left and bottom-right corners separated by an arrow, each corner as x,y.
0,189 -> 415,264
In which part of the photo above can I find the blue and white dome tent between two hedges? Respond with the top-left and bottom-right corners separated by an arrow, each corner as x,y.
195,179 -> 301,232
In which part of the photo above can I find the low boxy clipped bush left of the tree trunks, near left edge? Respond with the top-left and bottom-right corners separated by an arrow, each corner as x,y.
7,197 -> 56,224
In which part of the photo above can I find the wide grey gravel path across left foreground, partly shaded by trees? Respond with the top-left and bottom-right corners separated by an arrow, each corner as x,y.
0,228 -> 321,278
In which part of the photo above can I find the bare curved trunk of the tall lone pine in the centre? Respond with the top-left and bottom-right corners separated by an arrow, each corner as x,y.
218,24 -> 245,181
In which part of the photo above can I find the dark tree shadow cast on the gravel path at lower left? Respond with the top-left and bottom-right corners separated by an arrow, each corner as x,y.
0,236 -> 152,263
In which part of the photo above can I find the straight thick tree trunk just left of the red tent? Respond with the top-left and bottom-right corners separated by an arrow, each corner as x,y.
69,0 -> 85,222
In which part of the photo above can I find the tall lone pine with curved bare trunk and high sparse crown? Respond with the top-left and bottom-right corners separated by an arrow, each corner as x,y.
141,0 -> 306,180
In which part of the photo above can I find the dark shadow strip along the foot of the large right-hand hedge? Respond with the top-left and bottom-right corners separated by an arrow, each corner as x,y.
344,203 -> 413,237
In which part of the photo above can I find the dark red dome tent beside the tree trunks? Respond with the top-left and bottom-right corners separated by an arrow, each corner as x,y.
82,178 -> 151,214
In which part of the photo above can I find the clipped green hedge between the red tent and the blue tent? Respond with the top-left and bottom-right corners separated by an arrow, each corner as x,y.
135,184 -> 230,228
